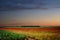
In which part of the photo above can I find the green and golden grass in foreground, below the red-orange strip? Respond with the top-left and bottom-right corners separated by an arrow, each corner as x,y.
0,30 -> 60,40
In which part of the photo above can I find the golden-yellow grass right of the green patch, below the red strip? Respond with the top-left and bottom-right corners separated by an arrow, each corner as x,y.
10,31 -> 60,40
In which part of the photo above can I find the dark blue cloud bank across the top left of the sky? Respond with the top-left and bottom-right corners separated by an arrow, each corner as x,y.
0,0 -> 46,10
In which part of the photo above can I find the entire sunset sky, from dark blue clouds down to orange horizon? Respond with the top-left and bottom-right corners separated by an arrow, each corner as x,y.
0,0 -> 60,26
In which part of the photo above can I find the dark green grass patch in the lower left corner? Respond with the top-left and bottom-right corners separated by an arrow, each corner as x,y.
0,30 -> 27,40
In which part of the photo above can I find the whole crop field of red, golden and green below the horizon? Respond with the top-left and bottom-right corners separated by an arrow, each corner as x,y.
0,28 -> 60,40
